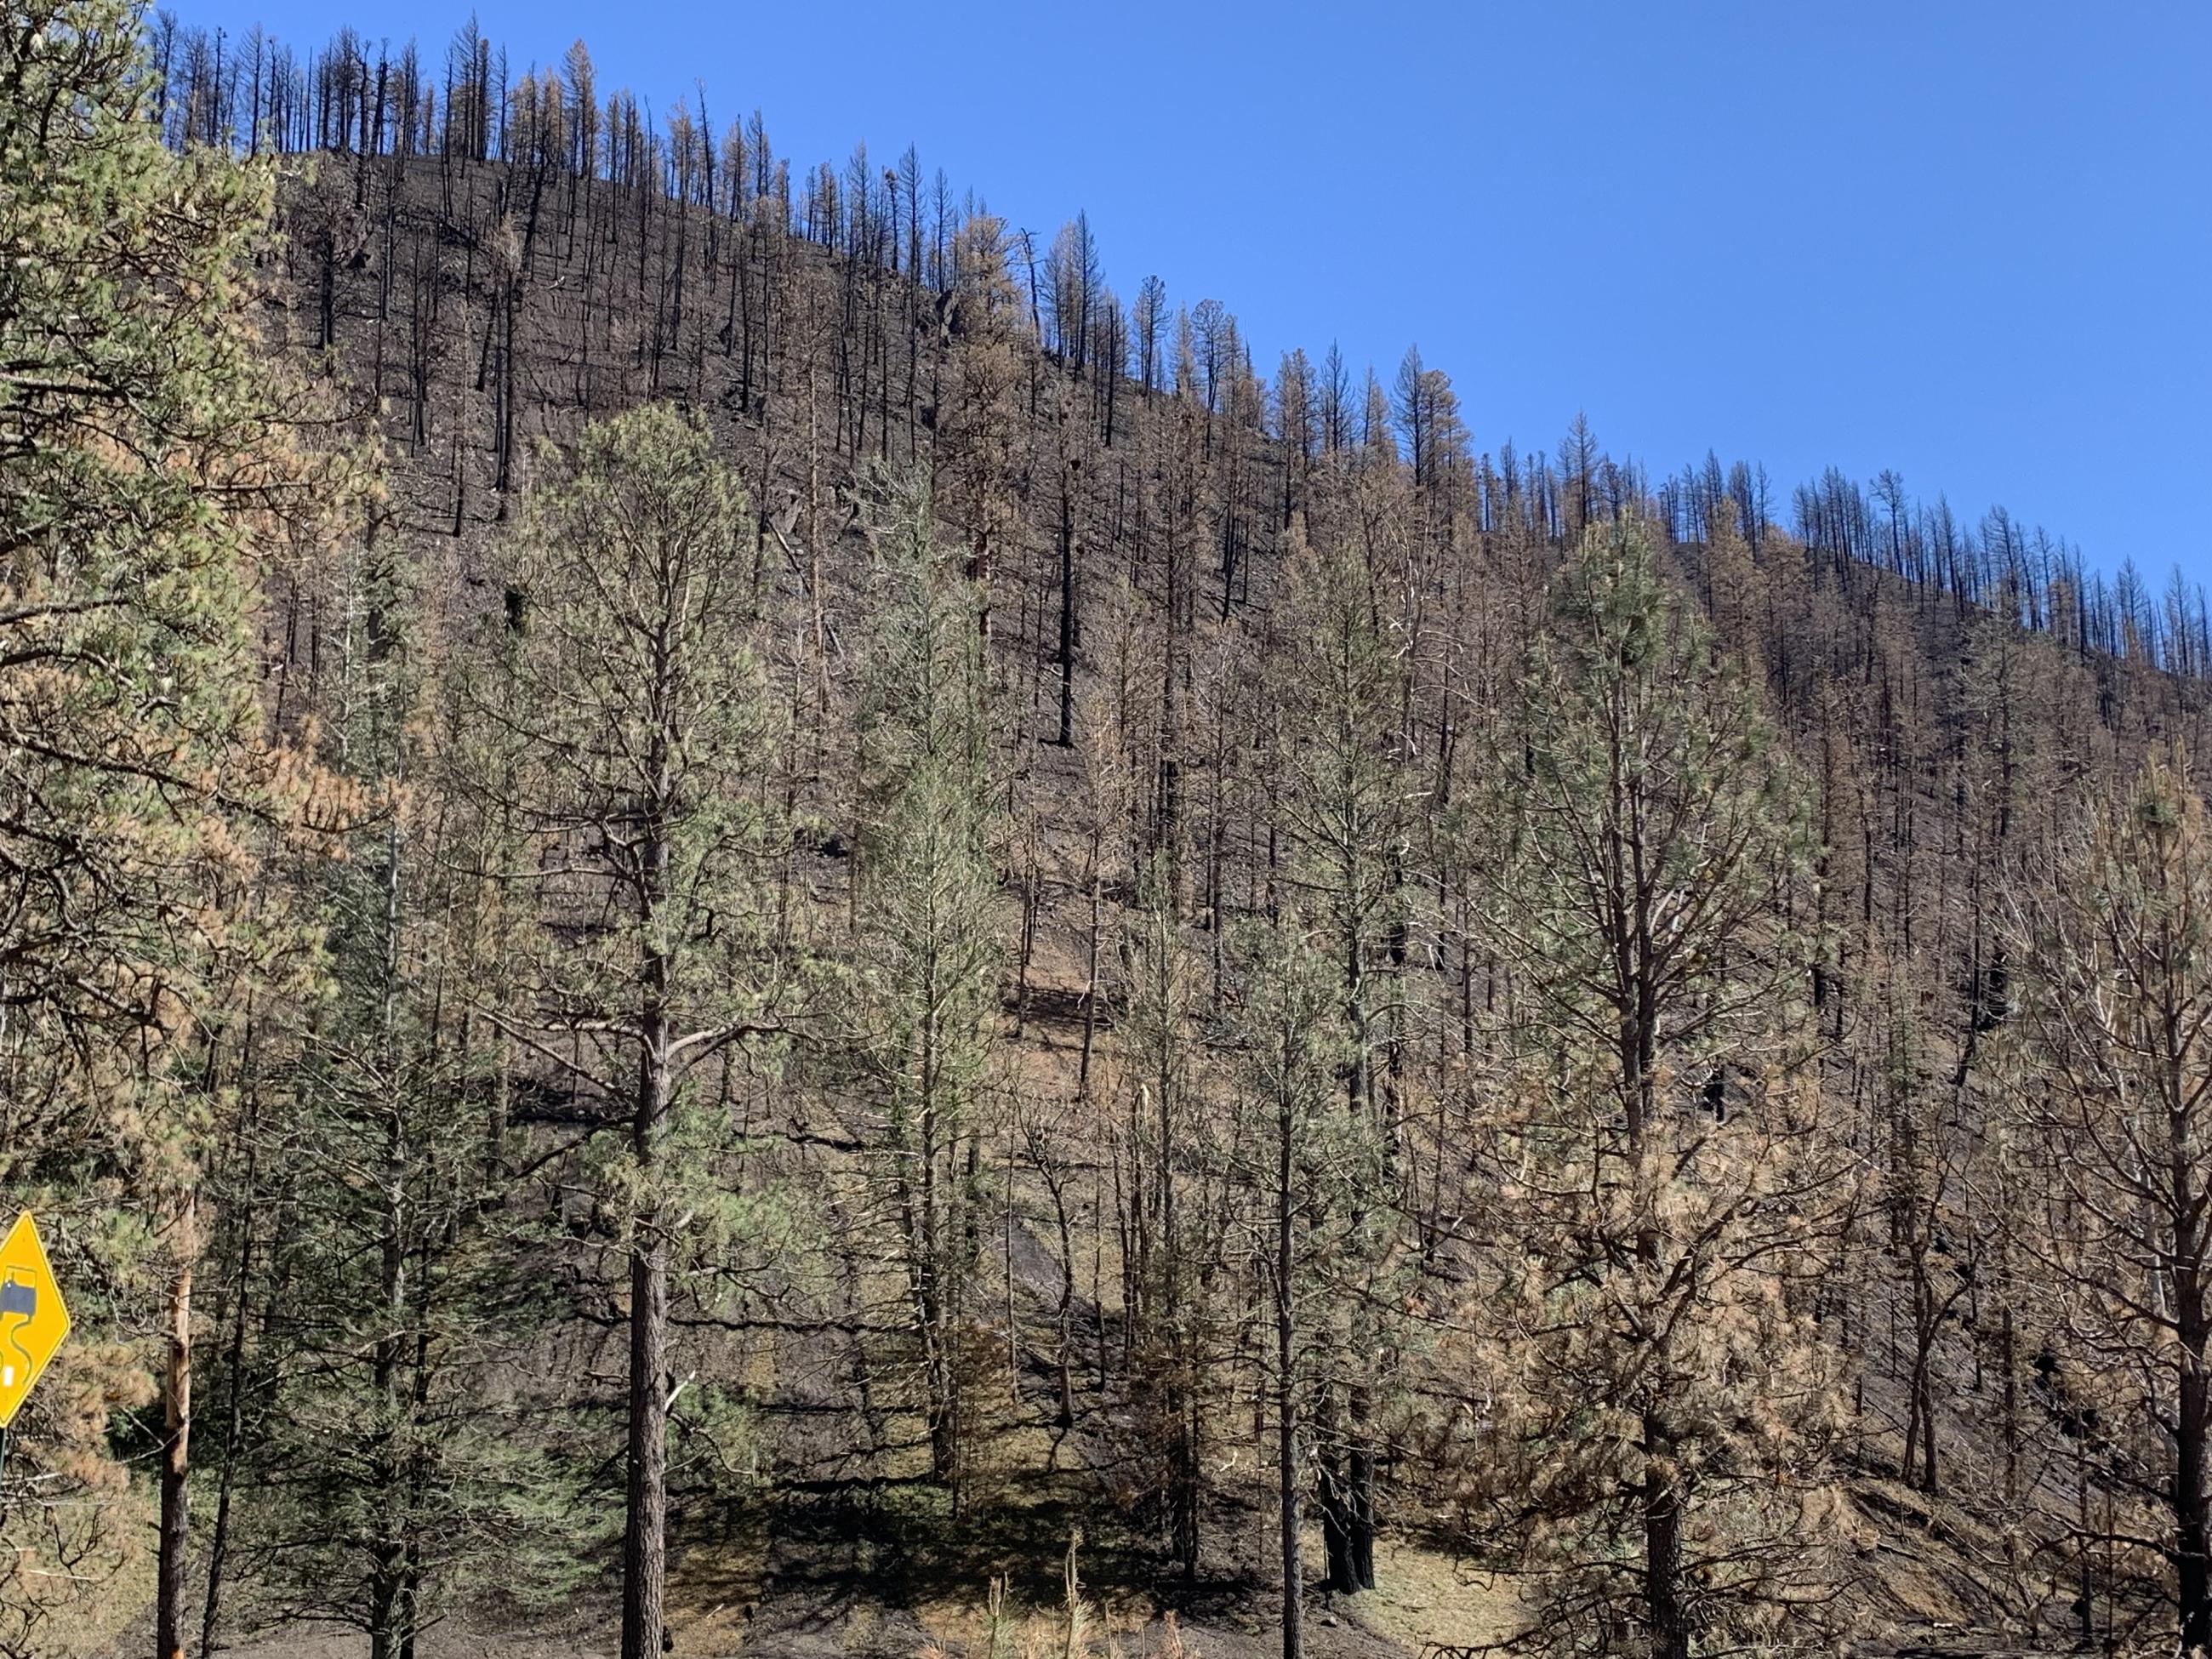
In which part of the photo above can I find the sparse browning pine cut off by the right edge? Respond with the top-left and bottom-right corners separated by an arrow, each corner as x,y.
2009,759 -> 2212,1652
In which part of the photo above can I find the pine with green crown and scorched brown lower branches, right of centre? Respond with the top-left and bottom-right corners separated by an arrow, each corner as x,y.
1486,520 -> 1836,1659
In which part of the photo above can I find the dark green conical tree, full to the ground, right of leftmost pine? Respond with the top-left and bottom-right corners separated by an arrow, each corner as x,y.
203,539 -> 606,1659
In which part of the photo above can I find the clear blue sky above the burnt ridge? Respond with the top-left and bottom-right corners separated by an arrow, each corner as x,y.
177,0 -> 2212,579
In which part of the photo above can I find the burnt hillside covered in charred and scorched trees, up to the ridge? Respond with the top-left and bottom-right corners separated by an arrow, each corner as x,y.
13,9 -> 2212,1659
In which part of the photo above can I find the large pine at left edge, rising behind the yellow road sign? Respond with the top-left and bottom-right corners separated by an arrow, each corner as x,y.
0,0 -> 343,1659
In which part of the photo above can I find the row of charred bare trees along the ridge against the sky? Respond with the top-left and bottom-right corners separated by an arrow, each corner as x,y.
152,11 -> 2212,672
